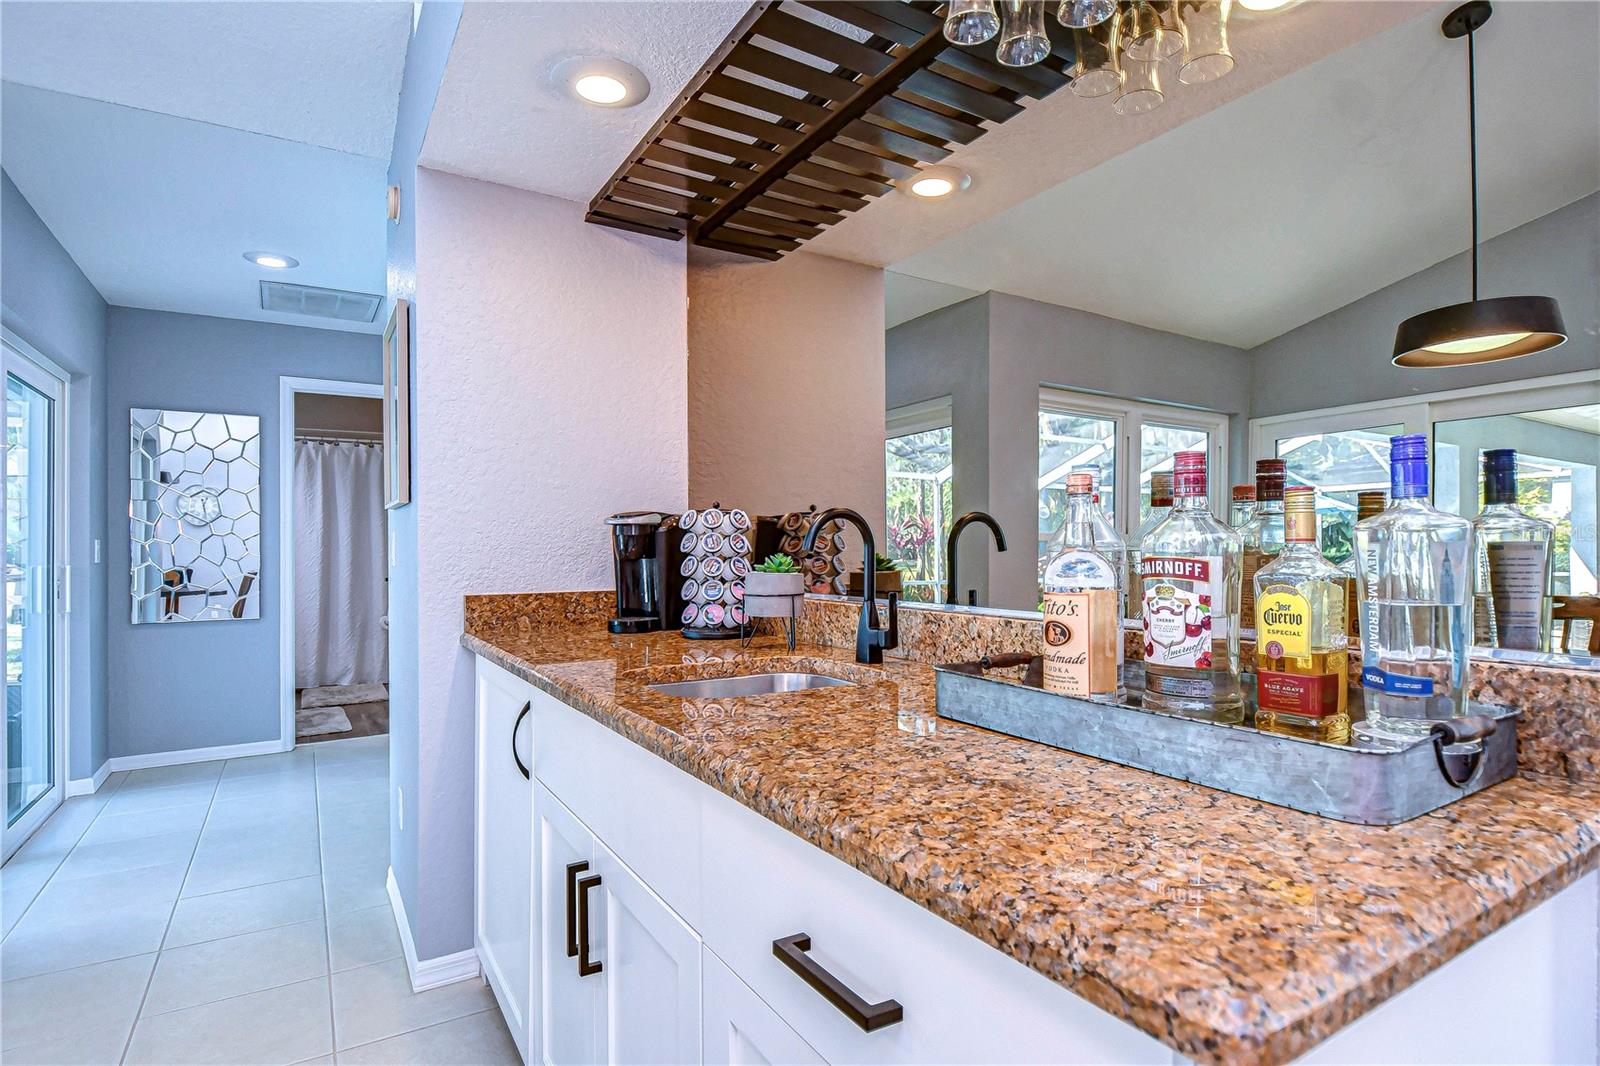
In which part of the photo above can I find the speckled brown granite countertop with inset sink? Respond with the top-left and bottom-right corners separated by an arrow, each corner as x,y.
462,619 -> 1600,1063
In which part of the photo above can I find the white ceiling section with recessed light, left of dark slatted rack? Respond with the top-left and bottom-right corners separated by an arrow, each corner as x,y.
419,0 -> 747,202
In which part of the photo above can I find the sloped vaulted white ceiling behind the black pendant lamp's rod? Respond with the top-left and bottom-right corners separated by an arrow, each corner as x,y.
889,0 -> 1600,347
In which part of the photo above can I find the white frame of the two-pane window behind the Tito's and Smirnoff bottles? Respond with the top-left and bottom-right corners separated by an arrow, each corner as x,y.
1034,384 -> 1229,539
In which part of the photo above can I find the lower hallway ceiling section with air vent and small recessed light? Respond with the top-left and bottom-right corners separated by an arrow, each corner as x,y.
0,87 -> 389,333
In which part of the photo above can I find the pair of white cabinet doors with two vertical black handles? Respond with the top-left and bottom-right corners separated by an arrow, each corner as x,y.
534,784 -> 701,1066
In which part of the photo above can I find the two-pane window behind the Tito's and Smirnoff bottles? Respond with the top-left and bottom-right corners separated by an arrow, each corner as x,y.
1037,386 -> 1227,589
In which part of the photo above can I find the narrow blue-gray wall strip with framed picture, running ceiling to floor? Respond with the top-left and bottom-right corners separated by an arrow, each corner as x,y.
384,0 -> 472,959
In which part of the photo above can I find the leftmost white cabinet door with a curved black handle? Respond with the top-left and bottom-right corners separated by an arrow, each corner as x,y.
474,658 -> 533,1060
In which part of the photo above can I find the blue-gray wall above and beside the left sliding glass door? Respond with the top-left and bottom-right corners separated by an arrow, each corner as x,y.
0,171 -> 109,779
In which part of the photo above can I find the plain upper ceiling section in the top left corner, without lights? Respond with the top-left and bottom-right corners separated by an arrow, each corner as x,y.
0,0 -> 411,160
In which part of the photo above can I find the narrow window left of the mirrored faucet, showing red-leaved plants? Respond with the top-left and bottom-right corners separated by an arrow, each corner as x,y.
883,397 -> 955,603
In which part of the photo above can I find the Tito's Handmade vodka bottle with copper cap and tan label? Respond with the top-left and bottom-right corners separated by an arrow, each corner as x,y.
1043,472 -> 1126,703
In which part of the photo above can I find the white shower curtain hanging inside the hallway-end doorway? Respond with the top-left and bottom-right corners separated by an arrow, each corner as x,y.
294,440 -> 389,688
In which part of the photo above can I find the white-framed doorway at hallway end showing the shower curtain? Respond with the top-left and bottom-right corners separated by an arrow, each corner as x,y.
280,378 -> 389,744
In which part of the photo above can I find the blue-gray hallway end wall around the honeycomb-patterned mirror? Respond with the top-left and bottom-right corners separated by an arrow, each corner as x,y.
104,307 -> 382,757
